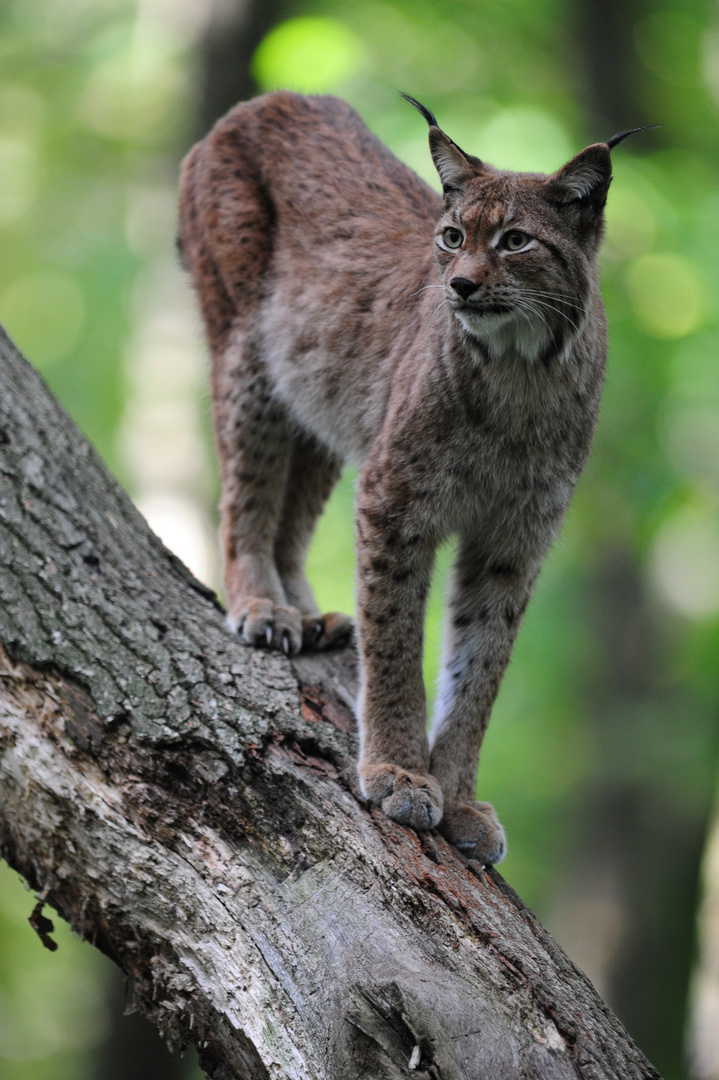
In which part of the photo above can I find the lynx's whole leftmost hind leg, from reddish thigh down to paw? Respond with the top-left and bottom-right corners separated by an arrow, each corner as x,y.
179,131 -> 302,654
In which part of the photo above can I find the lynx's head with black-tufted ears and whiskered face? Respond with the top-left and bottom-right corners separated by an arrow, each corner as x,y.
403,95 -> 641,362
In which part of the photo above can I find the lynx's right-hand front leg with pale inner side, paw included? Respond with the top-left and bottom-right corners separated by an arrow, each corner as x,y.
431,544 -> 535,863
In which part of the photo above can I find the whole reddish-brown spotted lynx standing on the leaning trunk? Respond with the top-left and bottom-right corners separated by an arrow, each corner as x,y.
179,92 -> 630,864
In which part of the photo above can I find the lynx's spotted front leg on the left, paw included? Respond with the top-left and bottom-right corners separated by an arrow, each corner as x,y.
357,470 -> 443,829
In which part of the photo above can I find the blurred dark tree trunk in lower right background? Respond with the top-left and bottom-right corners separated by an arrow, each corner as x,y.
560,550 -> 704,1076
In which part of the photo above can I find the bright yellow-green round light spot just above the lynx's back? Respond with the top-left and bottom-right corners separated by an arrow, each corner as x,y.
252,15 -> 365,94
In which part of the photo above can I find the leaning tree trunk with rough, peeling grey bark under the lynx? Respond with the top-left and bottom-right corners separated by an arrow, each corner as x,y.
0,321 -> 659,1080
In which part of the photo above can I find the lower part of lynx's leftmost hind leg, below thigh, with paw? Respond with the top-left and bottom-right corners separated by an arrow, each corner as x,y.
213,330 -> 302,656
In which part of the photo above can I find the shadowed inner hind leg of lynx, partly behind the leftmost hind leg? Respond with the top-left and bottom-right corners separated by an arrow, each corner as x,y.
274,432 -> 353,651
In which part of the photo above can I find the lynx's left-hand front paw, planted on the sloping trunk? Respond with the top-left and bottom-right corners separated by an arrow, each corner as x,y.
360,765 -> 443,832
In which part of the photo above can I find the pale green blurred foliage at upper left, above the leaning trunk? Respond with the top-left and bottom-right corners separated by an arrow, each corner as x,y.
0,0 -> 189,477
